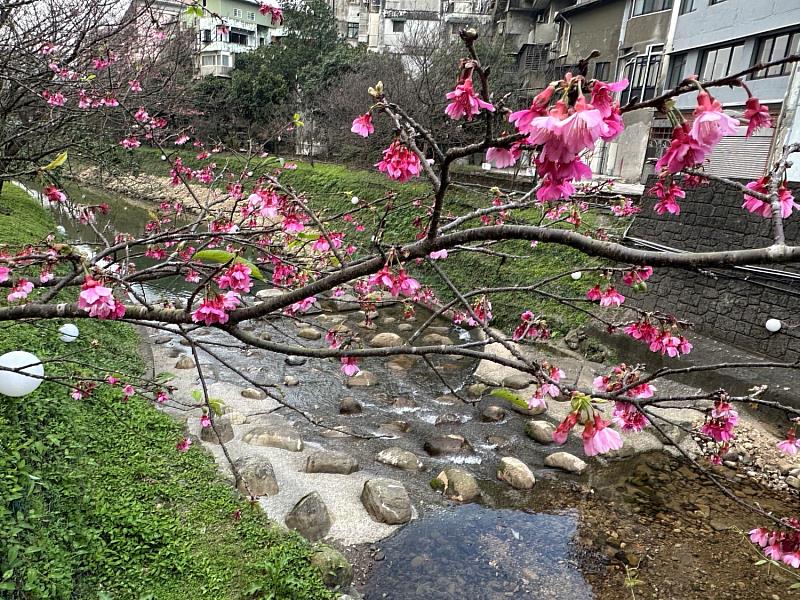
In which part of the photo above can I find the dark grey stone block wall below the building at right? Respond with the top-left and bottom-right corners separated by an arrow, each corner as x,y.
628,178 -> 800,360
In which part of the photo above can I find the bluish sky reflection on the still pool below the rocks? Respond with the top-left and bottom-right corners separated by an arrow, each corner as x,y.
364,504 -> 592,600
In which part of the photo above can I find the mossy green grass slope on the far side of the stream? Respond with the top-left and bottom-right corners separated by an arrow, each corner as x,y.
123,150 -> 608,333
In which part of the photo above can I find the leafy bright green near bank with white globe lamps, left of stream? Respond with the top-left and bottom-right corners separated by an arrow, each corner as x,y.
0,184 -> 330,600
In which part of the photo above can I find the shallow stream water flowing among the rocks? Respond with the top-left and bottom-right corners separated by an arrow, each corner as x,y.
21,179 -> 796,600
